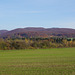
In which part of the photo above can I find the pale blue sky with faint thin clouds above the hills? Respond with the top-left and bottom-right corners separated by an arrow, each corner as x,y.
0,0 -> 75,30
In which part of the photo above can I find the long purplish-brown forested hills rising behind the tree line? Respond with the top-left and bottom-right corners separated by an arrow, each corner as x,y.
0,27 -> 75,38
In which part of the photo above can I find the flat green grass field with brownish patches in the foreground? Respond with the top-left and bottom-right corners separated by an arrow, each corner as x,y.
0,48 -> 75,75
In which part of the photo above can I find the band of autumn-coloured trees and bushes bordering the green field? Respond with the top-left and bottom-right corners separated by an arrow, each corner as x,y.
0,38 -> 75,50
